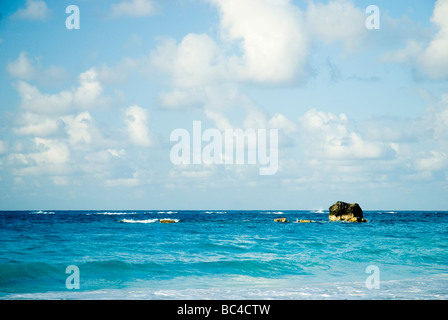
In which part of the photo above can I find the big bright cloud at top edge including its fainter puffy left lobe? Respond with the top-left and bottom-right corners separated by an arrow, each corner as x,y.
151,0 -> 309,87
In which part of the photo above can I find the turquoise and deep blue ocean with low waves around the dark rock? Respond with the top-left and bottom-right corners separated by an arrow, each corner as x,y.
0,210 -> 448,300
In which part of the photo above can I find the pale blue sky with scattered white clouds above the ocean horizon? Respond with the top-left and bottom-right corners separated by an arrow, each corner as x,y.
0,0 -> 448,210
